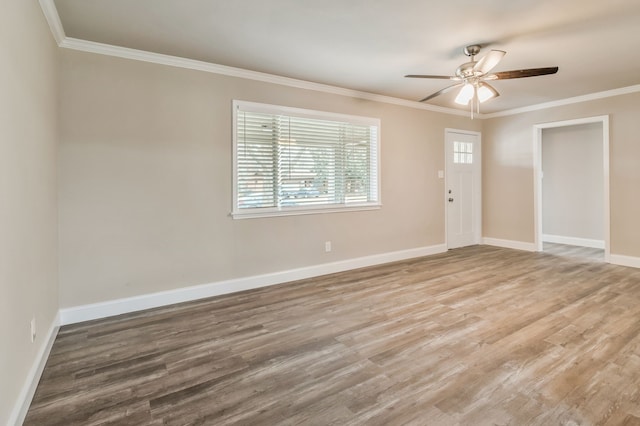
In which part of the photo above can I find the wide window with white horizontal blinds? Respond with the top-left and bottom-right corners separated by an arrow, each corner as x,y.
233,101 -> 380,217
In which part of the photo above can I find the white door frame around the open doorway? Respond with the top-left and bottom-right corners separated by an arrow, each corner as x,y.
533,115 -> 611,263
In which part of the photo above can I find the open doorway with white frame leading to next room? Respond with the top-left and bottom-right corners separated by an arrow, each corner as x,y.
533,116 -> 610,262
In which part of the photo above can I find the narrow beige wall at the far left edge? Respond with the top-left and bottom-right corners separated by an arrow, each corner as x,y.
0,0 -> 58,425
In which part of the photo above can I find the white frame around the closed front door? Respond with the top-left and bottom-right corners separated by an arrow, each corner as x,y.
442,127 -> 482,249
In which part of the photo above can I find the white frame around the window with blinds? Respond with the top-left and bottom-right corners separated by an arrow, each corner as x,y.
231,100 -> 382,219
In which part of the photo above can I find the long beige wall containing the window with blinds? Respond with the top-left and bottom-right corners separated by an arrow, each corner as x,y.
59,50 -> 481,307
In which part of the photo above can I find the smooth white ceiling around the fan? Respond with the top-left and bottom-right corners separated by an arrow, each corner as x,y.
55,0 -> 640,113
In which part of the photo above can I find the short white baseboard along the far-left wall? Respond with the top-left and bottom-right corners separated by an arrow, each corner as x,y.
7,315 -> 60,426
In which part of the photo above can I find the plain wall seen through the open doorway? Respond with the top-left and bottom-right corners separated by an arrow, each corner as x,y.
542,123 -> 604,241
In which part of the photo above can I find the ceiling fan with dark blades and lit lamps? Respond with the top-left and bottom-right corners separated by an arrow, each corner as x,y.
405,44 -> 558,118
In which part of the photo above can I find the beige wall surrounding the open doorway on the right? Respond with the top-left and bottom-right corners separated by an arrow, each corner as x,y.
483,93 -> 640,257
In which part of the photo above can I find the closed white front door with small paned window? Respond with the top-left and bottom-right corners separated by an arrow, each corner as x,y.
445,129 -> 481,249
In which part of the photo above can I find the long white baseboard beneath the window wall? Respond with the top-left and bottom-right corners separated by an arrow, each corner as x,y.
60,244 -> 447,325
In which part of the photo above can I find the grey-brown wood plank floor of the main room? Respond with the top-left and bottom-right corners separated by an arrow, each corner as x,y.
25,246 -> 640,425
